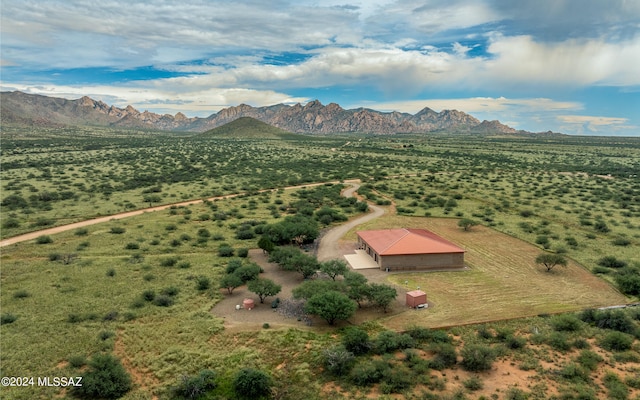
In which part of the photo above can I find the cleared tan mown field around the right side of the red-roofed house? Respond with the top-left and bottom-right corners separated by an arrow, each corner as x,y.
346,216 -> 628,329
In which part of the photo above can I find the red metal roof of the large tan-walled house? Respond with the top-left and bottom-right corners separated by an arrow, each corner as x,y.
357,228 -> 464,256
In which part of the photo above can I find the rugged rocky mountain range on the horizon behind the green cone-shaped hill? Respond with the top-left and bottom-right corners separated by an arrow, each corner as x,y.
0,92 -> 540,134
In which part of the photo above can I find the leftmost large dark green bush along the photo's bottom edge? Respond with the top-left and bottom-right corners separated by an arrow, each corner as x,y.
71,354 -> 131,399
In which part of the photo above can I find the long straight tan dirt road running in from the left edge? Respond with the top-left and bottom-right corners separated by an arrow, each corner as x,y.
0,179 -> 360,247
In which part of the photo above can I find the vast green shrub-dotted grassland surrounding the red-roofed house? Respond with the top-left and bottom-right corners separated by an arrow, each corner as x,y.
0,127 -> 640,399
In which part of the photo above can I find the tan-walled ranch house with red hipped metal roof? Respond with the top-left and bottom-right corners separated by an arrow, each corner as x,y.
357,228 -> 464,271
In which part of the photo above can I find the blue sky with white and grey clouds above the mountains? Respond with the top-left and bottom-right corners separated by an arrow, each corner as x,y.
0,0 -> 640,136
